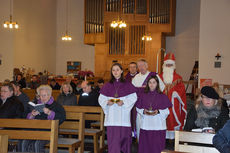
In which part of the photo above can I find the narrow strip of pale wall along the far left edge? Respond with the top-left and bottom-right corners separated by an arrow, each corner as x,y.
0,0 -> 15,82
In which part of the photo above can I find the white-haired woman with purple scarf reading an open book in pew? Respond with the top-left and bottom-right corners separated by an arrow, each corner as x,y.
22,85 -> 66,153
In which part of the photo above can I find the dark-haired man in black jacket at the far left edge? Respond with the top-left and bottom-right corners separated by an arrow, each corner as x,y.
0,83 -> 24,118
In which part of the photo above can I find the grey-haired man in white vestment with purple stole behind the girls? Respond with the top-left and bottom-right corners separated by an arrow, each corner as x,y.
132,59 -> 164,139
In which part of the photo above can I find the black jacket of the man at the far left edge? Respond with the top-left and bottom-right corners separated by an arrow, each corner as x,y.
0,96 -> 24,118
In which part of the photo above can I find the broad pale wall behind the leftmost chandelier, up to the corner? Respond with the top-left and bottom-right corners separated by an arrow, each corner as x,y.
0,0 -> 56,82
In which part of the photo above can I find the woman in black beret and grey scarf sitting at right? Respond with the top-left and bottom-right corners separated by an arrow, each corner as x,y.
184,86 -> 229,132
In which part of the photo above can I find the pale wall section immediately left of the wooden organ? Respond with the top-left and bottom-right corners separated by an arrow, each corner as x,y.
56,0 -> 94,75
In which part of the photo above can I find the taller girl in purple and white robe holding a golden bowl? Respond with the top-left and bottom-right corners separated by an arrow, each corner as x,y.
98,63 -> 137,153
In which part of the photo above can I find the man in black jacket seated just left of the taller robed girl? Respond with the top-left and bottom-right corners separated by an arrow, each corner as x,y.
78,81 -> 99,106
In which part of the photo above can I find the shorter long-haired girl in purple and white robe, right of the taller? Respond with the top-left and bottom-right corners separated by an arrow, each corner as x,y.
136,76 -> 172,153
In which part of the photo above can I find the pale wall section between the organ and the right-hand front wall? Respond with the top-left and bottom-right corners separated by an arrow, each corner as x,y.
166,0 -> 200,81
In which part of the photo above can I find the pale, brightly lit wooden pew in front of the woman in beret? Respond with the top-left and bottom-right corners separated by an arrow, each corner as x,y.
175,131 -> 218,153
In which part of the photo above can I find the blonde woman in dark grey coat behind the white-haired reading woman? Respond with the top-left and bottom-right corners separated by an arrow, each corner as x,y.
57,82 -> 77,106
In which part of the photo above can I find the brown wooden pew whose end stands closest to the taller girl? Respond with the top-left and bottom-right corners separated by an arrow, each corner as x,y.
59,106 -> 105,153
